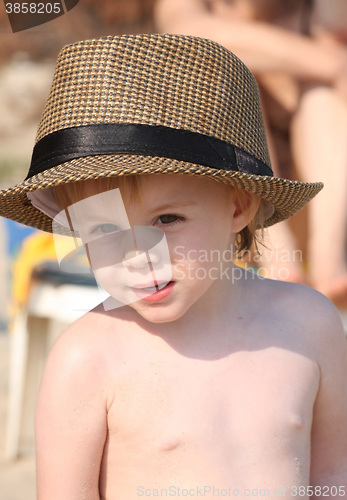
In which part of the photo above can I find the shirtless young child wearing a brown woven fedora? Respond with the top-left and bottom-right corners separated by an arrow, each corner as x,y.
0,35 -> 347,500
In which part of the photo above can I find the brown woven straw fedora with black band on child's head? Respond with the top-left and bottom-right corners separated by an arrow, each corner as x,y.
0,34 -> 323,231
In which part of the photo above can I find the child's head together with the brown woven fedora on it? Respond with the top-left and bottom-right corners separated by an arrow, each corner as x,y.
0,35 -> 322,321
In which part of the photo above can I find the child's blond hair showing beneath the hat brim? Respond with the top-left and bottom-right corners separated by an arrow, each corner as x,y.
53,174 -> 264,257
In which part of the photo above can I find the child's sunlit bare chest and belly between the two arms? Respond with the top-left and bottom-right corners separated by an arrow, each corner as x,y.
101,336 -> 319,498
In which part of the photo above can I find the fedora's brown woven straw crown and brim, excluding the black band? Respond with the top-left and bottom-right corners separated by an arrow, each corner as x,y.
0,35 -> 322,231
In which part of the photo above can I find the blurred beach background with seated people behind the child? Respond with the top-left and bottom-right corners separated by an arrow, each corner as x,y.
0,0 -> 347,500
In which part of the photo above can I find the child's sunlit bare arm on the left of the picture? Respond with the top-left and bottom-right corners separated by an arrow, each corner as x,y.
36,322 -> 107,500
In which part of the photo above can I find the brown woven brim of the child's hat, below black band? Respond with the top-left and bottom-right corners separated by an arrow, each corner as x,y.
0,154 -> 323,232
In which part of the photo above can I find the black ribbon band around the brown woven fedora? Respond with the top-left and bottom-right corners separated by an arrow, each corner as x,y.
27,123 -> 273,179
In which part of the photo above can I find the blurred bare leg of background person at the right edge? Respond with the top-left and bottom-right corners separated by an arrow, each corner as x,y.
291,87 -> 347,305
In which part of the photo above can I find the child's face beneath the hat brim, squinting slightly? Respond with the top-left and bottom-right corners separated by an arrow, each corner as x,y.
62,175 -> 246,322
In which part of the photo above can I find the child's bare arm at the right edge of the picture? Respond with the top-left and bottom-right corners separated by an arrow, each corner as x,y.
311,294 -> 347,498
